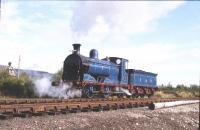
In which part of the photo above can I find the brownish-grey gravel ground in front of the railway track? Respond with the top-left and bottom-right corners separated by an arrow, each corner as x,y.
0,104 -> 199,130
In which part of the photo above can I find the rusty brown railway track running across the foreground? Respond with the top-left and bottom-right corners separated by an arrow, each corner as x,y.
0,98 -> 197,119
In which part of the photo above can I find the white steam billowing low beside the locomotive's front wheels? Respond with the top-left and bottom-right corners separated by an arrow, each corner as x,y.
34,78 -> 82,99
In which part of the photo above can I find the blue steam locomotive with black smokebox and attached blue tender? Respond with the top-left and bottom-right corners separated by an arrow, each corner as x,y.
62,44 -> 157,98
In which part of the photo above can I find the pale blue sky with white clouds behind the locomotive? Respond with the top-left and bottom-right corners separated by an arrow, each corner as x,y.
0,0 -> 200,85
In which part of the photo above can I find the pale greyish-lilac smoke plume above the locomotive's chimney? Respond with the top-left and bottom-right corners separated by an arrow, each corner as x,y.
71,2 -> 117,34
